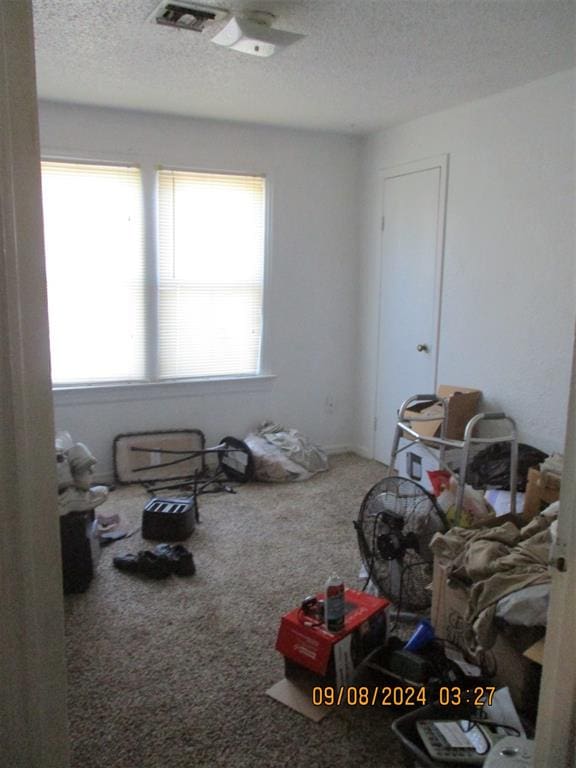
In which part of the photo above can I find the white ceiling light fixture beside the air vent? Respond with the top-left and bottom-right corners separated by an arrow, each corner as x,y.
212,11 -> 305,56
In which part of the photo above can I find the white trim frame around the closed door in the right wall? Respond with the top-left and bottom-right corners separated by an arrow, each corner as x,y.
371,153 -> 450,458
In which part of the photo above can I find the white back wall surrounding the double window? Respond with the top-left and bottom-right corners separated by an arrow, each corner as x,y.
40,103 -> 359,475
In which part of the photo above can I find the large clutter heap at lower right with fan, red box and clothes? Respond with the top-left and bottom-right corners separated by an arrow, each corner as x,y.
268,420 -> 562,765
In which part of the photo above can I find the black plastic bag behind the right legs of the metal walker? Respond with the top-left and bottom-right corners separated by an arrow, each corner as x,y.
467,443 -> 548,491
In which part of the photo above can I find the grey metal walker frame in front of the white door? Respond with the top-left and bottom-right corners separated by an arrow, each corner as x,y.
388,395 -> 518,519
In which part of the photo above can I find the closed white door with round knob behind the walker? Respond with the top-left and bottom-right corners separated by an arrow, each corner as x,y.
374,156 -> 447,463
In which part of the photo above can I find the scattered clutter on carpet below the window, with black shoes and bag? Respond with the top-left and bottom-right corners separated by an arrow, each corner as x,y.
55,423 -> 328,593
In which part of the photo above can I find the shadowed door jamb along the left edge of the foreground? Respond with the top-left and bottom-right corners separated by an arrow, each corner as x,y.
0,0 -> 70,768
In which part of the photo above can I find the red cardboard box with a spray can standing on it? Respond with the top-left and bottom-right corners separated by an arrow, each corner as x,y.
276,589 -> 389,686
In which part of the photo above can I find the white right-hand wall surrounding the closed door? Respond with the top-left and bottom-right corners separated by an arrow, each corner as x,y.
355,71 -> 576,455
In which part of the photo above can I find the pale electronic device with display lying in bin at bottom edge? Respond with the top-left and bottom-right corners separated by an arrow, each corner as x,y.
416,720 -> 514,768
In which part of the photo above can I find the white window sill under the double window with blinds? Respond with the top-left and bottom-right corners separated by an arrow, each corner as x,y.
52,374 -> 276,406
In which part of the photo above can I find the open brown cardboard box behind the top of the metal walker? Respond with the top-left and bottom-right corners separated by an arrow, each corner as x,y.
405,384 -> 482,440
